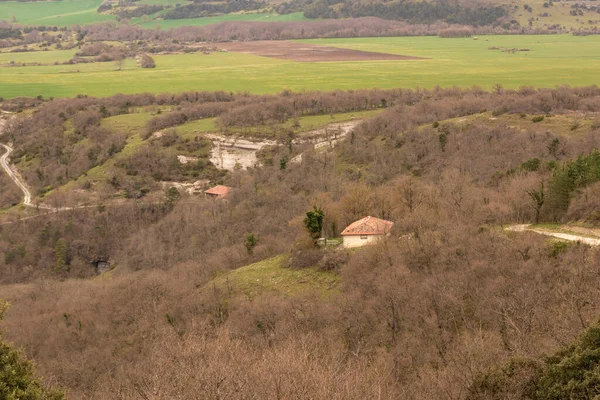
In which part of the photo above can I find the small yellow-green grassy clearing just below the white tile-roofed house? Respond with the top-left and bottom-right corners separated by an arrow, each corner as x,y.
207,255 -> 339,297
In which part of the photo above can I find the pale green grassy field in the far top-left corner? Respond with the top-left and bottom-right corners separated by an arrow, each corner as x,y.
0,0 -> 115,26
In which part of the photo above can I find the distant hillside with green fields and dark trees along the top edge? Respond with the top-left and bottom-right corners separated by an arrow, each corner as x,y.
0,0 -> 600,31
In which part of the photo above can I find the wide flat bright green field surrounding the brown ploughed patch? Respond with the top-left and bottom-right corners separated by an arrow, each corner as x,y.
0,35 -> 600,98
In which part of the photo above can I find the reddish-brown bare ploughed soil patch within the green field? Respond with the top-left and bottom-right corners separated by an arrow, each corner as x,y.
219,40 -> 427,62
